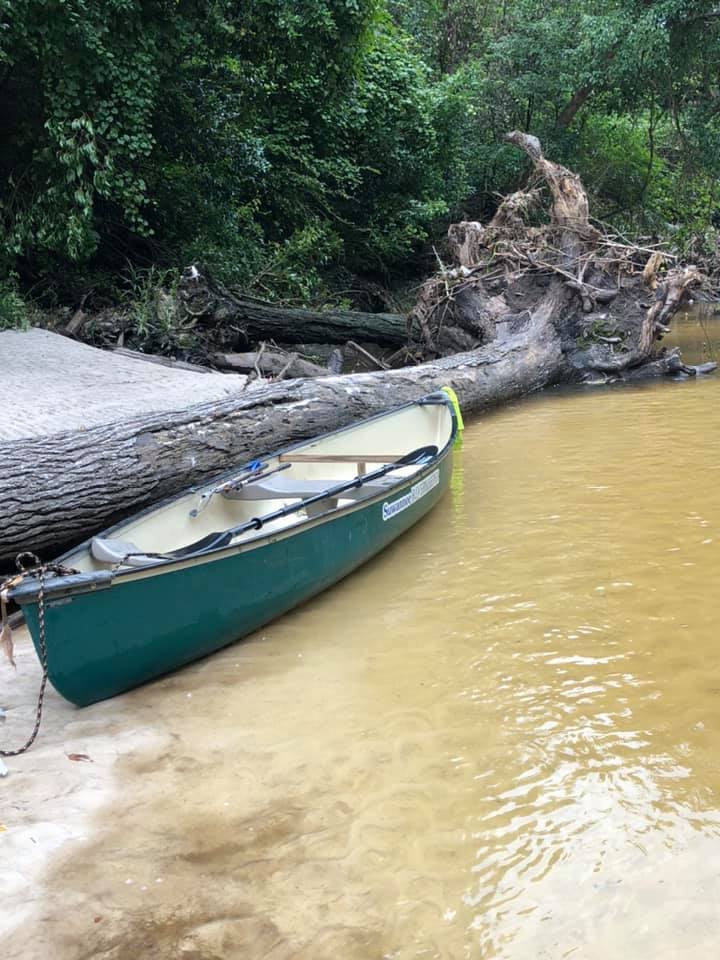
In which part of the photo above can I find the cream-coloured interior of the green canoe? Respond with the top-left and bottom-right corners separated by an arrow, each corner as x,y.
62,403 -> 453,572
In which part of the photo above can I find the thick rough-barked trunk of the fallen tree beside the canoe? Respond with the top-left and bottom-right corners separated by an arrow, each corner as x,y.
0,324 -> 562,565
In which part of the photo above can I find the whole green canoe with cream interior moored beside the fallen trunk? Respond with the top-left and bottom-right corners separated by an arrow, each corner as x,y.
11,393 -> 457,706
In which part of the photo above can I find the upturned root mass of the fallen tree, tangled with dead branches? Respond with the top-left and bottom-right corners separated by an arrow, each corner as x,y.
412,132 -> 704,379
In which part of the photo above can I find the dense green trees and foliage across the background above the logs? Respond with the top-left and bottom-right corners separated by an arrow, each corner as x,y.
0,0 -> 720,314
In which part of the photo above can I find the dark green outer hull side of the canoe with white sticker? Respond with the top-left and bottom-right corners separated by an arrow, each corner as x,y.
24,450 -> 451,706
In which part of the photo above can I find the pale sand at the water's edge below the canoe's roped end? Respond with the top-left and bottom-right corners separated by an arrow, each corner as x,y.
0,629 -> 163,960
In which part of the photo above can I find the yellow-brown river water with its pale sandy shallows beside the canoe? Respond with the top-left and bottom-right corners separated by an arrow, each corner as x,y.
0,310 -> 720,960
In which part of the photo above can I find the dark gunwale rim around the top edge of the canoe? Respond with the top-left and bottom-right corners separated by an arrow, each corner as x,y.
8,392 -> 458,606
